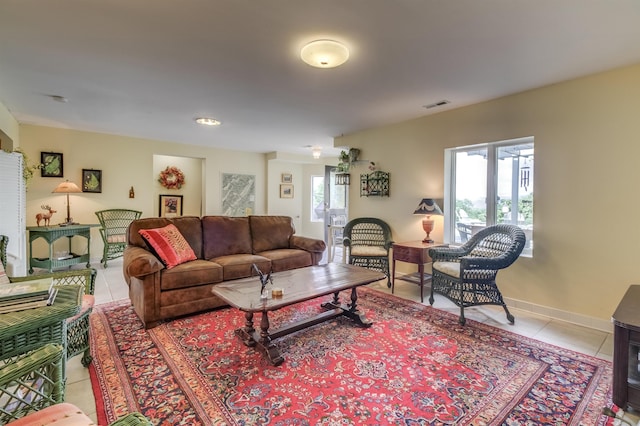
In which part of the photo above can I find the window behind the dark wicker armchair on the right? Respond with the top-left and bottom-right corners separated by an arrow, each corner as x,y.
445,137 -> 534,256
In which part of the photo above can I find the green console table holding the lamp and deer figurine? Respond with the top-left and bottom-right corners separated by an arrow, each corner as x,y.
27,225 -> 92,274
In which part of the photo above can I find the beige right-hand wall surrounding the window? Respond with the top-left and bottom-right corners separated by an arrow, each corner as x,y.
336,64 -> 640,328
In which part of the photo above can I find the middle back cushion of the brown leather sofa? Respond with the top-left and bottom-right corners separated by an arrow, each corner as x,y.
202,216 -> 252,260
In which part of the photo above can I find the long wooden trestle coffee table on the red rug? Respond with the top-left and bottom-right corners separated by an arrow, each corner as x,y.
212,263 -> 386,365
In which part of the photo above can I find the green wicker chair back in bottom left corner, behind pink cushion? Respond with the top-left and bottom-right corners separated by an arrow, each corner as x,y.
0,343 -> 64,425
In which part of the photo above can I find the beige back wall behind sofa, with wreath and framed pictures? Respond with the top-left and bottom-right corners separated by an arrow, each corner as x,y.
20,125 -> 267,258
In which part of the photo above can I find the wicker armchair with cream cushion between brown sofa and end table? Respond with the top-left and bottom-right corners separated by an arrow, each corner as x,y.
342,217 -> 393,288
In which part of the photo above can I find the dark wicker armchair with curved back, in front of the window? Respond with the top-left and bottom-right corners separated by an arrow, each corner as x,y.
429,224 -> 525,325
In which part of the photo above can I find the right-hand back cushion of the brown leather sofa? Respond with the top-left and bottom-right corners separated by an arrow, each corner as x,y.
249,216 -> 295,253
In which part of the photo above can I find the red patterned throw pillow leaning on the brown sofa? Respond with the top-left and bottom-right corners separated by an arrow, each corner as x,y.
138,224 -> 197,269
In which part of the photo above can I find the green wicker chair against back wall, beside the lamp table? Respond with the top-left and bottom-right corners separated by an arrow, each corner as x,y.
96,209 -> 142,268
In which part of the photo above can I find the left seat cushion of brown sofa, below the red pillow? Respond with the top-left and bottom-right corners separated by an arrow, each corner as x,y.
160,260 -> 222,291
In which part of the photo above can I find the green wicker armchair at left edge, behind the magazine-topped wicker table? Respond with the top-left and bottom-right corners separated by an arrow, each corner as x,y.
0,235 -> 97,367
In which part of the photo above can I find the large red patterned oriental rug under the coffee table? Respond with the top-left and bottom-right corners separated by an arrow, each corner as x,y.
91,288 -> 612,425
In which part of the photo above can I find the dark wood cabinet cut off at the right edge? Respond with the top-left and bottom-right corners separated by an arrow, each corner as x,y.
612,285 -> 640,410
